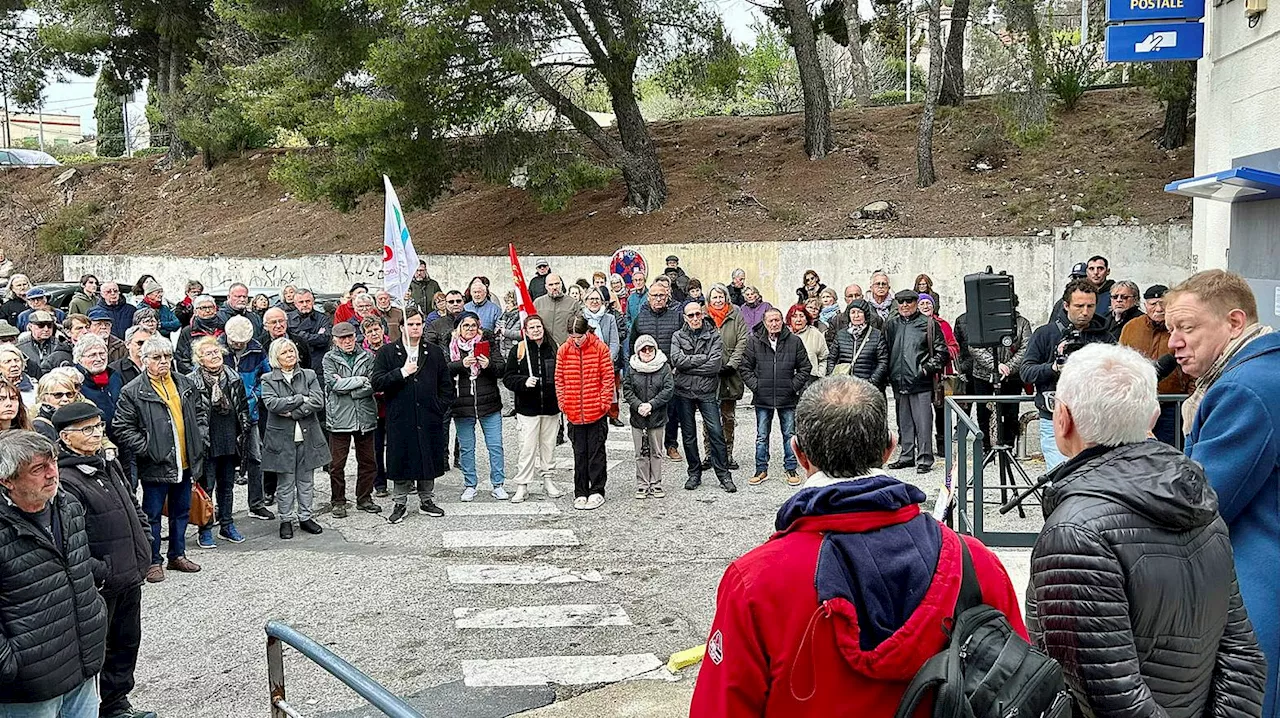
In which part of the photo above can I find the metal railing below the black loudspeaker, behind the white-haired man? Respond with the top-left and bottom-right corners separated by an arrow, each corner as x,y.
942,394 -> 1187,548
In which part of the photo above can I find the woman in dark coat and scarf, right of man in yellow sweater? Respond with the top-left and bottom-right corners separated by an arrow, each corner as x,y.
188,337 -> 250,549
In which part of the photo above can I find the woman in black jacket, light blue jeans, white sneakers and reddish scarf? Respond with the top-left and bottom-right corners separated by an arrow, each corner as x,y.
449,311 -> 507,502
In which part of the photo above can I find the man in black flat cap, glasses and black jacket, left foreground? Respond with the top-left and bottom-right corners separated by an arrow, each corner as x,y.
52,402 -> 155,718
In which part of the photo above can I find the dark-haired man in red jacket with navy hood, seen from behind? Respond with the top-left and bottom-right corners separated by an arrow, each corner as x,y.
690,376 -> 1027,718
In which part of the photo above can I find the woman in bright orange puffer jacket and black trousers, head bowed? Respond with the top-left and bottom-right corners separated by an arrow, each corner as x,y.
556,315 -> 613,509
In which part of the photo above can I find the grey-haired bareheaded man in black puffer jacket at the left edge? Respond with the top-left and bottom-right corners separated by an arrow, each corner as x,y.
0,431 -> 106,715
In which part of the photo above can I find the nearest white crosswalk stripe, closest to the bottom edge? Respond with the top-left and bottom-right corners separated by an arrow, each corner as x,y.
462,653 -> 662,687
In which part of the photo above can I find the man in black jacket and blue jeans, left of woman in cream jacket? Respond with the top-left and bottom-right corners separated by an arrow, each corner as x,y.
737,308 -> 813,486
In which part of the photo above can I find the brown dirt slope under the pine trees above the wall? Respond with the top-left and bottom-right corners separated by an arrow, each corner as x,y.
0,90 -> 1192,268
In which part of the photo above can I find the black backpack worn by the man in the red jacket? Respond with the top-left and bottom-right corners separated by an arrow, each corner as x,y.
893,538 -> 1074,718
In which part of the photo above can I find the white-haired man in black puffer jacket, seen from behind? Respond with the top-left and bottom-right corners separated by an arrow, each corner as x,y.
1027,344 -> 1266,718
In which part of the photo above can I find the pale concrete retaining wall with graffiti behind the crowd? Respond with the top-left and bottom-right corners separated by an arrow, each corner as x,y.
63,225 -> 1198,323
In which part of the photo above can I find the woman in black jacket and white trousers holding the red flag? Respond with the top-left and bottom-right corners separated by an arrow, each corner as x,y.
502,314 -> 563,503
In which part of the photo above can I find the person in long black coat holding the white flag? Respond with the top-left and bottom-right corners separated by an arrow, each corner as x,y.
372,306 -> 457,523
